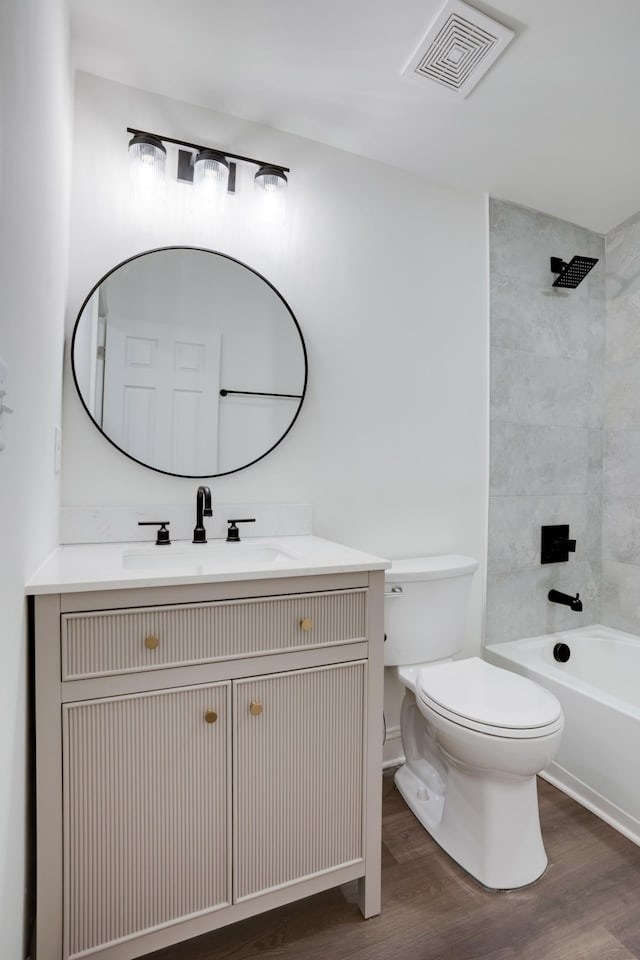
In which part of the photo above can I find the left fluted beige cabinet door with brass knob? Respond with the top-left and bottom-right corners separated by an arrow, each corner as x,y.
63,683 -> 231,958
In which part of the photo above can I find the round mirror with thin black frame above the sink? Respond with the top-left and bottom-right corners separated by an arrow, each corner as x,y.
71,247 -> 307,477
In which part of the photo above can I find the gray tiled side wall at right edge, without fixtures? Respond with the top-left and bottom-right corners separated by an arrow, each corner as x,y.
602,214 -> 640,634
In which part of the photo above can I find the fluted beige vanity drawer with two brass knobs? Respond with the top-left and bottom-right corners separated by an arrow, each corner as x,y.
61,589 -> 367,680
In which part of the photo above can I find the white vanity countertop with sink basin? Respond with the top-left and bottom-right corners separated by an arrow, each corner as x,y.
25,536 -> 391,594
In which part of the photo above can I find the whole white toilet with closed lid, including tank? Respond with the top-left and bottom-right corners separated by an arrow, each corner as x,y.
384,555 -> 564,890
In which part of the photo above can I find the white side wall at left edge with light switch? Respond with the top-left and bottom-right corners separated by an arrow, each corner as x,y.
0,0 -> 71,960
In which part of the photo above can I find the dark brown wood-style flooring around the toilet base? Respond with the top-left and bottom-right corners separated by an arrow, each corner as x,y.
148,771 -> 640,960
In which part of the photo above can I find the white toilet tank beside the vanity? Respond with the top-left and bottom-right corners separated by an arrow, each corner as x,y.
384,554 -> 478,666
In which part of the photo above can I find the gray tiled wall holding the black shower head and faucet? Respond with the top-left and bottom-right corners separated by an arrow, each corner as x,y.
486,200 -> 604,643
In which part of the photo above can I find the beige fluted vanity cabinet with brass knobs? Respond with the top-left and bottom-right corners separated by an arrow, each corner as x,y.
34,571 -> 383,960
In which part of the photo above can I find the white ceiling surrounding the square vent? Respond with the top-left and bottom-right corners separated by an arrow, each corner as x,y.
70,0 -> 640,232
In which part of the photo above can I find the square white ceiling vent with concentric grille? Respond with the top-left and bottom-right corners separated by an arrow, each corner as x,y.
402,0 -> 515,98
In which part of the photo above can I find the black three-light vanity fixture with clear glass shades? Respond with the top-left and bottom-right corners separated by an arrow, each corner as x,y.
127,127 -> 289,193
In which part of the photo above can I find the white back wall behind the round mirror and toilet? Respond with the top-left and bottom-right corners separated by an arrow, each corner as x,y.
62,74 -> 488,756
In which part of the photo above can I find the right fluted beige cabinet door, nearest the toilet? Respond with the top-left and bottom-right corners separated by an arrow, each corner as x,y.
233,661 -> 366,902
